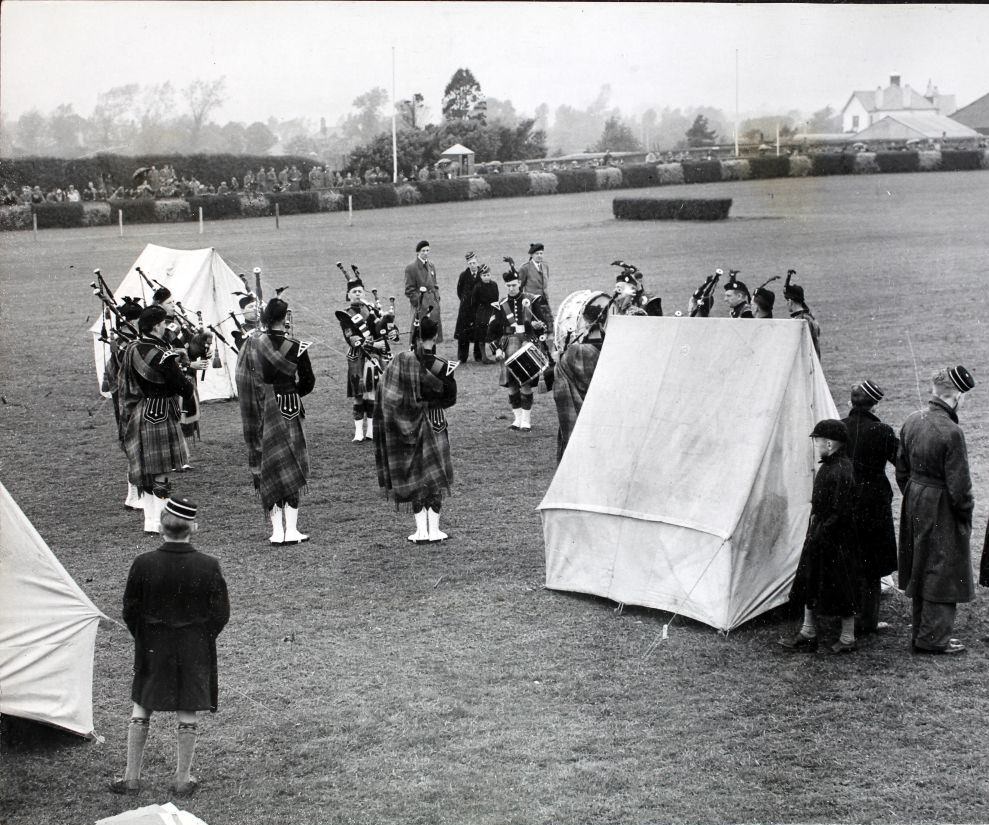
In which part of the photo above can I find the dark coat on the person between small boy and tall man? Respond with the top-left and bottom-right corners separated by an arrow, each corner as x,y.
842,407 -> 899,579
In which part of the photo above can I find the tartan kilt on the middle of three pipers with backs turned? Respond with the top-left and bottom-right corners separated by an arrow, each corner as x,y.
258,389 -> 309,511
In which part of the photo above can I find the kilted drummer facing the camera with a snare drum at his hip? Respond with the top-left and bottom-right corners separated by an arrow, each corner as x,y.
487,267 -> 553,431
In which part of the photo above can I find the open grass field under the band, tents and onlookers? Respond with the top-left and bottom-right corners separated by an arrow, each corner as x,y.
0,172 -> 989,825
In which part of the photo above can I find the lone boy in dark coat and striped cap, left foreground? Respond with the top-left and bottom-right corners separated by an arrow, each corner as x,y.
110,498 -> 230,797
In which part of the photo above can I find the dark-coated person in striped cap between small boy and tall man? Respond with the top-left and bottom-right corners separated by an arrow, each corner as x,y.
842,380 -> 899,633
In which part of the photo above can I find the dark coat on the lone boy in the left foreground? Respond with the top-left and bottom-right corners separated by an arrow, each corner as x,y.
124,541 -> 230,711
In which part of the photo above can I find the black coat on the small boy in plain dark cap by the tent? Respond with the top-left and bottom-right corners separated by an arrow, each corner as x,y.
790,450 -> 858,616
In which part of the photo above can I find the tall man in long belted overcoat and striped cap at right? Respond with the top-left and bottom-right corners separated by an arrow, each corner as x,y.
896,366 -> 975,653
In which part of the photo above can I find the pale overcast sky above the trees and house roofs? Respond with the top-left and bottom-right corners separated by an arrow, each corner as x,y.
0,0 -> 989,125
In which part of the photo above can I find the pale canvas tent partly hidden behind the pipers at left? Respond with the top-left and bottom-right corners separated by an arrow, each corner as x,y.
89,244 -> 244,401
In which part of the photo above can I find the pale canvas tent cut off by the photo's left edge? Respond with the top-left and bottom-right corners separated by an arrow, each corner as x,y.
0,484 -> 106,736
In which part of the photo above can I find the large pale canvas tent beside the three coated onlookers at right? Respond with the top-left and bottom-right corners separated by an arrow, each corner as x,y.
538,316 -> 838,631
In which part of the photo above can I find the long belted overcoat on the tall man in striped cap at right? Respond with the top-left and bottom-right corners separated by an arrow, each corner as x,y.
896,398 -> 975,604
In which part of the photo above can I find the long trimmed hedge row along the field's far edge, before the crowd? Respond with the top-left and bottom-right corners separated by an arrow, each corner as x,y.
0,150 -> 989,231
